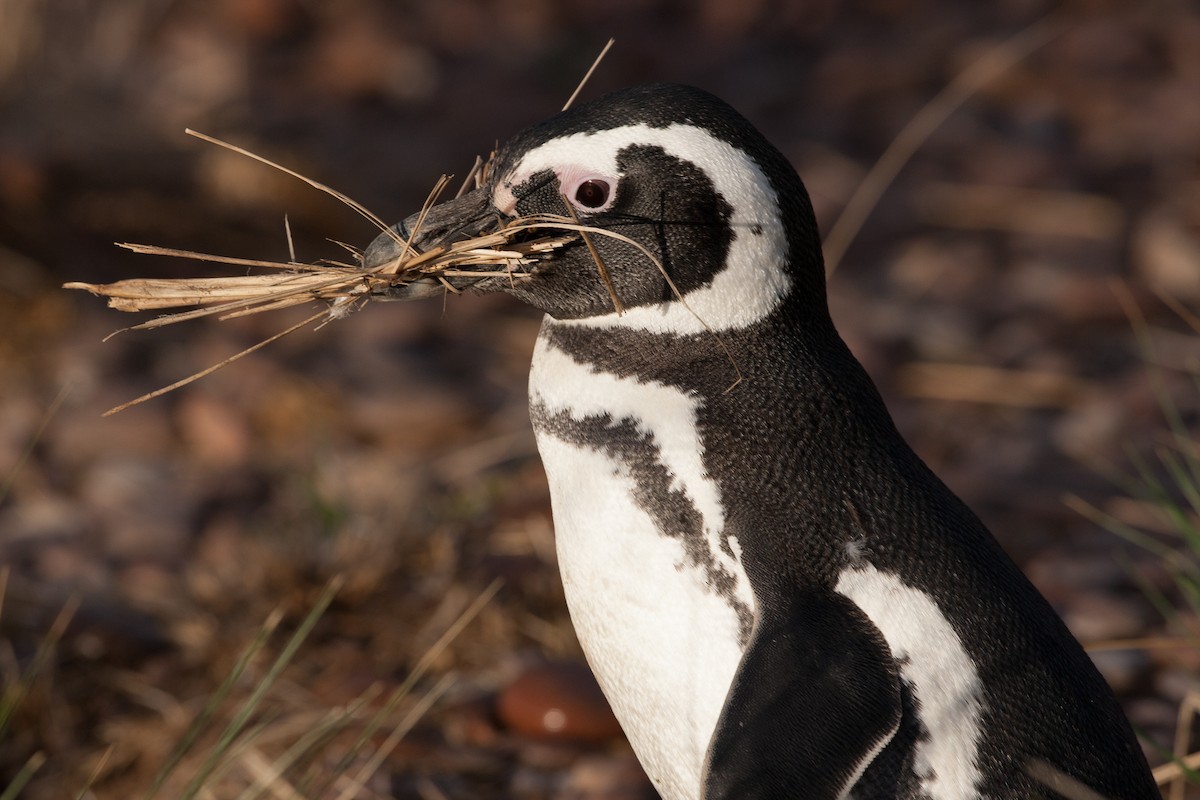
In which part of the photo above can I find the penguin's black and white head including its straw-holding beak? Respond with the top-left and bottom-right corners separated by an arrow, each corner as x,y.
364,85 -> 824,335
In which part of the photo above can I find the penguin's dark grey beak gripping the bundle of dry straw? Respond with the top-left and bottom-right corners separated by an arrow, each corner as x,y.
362,187 -> 504,300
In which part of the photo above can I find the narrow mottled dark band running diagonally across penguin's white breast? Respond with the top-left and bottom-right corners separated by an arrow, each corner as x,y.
529,403 -> 754,648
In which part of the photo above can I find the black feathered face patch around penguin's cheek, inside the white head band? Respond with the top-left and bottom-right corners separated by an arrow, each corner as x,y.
502,145 -> 734,319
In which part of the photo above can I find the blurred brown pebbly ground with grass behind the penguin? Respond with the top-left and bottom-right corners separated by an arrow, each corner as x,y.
0,0 -> 1200,800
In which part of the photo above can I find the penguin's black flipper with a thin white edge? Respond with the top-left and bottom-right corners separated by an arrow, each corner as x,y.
704,591 -> 901,800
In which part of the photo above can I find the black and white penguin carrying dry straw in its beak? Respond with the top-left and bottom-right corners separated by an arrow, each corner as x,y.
364,85 -> 1159,800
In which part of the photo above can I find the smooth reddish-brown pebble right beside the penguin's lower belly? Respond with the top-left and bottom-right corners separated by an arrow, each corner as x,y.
496,661 -> 620,741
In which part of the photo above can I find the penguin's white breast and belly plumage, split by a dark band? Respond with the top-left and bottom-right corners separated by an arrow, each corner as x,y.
529,326 -> 754,800
